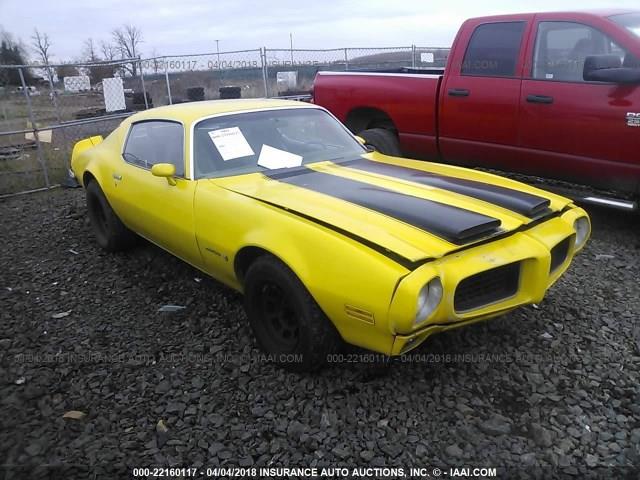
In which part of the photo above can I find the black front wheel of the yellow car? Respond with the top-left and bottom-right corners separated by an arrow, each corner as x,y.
244,255 -> 340,371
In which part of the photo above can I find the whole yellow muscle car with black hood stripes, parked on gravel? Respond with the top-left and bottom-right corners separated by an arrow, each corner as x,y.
71,100 -> 591,370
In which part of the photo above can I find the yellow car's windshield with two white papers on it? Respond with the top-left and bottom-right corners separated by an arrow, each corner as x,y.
193,107 -> 366,178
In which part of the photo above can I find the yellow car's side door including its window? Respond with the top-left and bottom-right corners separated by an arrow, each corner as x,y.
113,120 -> 200,265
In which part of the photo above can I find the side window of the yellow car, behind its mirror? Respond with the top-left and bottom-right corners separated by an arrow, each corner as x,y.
122,120 -> 184,177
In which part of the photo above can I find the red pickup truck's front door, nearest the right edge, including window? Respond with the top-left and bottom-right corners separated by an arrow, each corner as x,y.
519,17 -> 640,191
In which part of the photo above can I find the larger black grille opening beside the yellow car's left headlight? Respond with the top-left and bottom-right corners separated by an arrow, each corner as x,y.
453,263 -> 520,312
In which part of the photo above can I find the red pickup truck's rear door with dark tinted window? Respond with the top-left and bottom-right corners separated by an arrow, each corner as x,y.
439,16 -> 530,167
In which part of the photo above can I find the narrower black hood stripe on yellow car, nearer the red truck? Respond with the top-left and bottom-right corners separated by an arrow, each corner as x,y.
338,159 -> 551,218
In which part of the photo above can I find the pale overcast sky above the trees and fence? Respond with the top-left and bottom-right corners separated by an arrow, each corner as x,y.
0,0 -> 640,61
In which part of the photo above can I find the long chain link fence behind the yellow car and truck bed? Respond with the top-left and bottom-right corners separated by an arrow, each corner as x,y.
0,46 -> 449,196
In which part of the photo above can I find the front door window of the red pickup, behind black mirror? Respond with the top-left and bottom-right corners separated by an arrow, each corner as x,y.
532,22 -> 627,82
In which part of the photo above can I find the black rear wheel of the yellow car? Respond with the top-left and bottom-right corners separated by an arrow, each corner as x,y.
87,181 -> 136,252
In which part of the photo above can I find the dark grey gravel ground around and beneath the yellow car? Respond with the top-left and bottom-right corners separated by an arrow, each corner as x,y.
0,190 -> 640,478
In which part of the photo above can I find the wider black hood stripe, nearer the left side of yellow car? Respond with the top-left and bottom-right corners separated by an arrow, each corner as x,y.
263,167 -> 501,245
